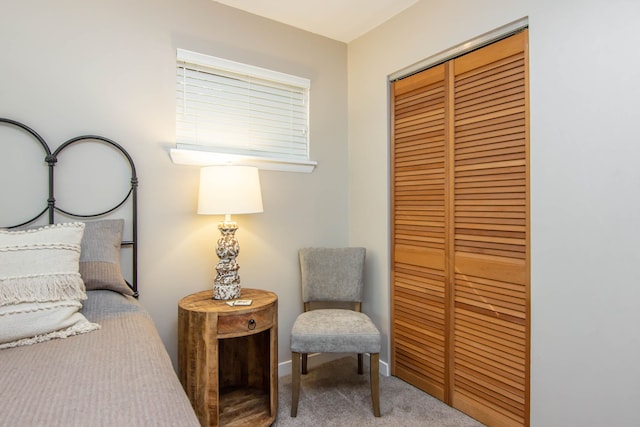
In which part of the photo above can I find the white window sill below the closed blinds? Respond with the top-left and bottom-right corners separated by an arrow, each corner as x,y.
169,148 -> 318,173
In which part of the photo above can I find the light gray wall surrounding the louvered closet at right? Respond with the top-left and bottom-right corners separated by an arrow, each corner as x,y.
349,0 -> 640,427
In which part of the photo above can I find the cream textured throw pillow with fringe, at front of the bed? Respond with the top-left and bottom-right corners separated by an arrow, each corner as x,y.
0,223 -> 99,348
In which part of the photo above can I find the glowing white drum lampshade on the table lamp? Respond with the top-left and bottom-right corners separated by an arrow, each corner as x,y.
198,166 -> 263,215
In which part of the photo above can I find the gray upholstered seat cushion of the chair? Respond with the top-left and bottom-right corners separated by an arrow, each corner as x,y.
291,309 -> 380,353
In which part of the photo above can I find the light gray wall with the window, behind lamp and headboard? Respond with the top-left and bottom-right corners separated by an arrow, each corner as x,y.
0,0 -> 348,368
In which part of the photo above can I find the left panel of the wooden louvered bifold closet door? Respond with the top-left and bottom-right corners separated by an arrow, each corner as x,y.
391,65 -> 447,400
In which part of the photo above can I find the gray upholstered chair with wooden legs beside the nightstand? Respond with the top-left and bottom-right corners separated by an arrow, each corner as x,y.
291,248 -> 380,417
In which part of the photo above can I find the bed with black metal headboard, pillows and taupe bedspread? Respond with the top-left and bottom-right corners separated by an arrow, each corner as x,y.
0,119 -> 199,427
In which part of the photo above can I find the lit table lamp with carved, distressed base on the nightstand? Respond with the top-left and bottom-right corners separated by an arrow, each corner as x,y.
198,166 -> 263,300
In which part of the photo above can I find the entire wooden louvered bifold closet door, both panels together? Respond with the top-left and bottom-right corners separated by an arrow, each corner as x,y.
391,30 -> 530,426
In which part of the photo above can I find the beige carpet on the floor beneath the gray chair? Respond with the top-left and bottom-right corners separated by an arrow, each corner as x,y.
273,357 -> 482,427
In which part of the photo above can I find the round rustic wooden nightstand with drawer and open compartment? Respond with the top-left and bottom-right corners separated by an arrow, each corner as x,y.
178,288 -> 278,426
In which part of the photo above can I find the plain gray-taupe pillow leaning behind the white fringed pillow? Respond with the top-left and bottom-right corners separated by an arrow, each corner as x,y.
80,219 -> 133,295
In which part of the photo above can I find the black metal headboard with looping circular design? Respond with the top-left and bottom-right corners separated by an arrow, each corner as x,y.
0,118 -> 138,297
